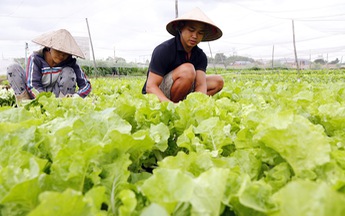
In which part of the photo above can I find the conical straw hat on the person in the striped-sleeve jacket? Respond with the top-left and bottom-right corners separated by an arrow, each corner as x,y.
32,29 -> 85,59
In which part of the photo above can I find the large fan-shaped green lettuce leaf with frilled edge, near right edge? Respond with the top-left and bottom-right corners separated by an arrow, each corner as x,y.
253,111 -> 331,178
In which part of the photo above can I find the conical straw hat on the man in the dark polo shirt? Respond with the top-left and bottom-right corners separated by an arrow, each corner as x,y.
166,8 -> 223,41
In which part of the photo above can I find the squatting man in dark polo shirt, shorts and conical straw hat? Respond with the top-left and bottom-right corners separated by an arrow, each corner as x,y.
142,8 -> 224,103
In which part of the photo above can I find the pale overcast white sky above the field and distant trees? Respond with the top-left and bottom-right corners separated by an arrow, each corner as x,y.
0,0 -> 345,62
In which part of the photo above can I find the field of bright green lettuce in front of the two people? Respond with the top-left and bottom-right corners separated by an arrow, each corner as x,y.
0,70 -> 345,216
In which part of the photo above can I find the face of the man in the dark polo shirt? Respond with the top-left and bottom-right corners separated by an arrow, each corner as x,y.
181,21 -> 205,50
